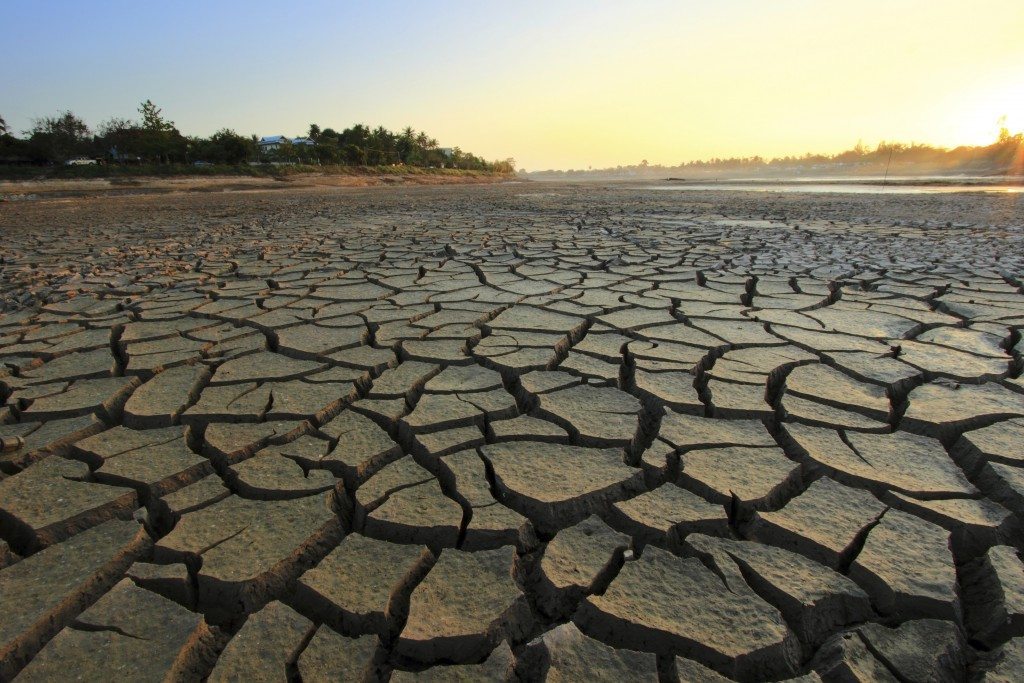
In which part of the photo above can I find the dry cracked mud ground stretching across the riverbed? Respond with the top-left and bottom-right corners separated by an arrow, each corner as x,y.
0,185 -> 1024,682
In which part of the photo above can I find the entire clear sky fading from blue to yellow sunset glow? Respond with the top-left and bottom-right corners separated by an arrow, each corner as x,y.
6,0 -> 1024,170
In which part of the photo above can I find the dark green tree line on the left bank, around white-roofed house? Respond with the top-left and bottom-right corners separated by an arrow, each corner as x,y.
0,99 -> 515,173
